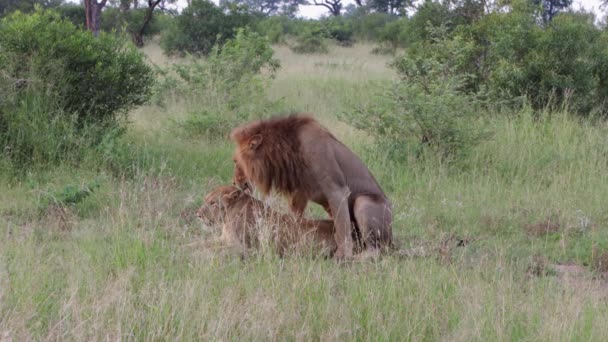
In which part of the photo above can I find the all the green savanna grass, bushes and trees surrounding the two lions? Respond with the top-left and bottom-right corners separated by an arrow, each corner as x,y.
0,0 -> 608,341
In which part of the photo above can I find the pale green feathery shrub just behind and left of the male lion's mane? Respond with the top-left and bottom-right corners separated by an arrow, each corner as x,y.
159,29 -> 279,137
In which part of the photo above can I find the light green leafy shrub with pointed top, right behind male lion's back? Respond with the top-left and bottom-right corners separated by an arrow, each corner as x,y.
343,29 -> 486,162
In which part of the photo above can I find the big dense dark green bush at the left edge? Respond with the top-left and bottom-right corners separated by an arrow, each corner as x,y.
0,9 -> 154,168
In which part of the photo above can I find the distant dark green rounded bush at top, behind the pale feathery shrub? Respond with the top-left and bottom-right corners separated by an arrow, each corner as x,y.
161,0 -> 253,55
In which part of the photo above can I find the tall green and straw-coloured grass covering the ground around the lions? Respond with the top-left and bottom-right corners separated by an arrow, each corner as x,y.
0,40 -> 608,341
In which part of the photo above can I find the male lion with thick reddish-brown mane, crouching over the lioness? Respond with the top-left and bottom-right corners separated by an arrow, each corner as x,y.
230,114 -> 392,258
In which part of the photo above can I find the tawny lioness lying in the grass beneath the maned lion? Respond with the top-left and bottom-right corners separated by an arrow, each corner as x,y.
196,186 -> 336,256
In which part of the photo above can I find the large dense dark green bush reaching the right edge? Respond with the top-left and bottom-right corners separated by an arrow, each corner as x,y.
458,6 -> 608,115
